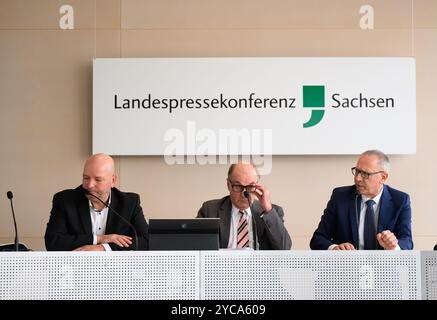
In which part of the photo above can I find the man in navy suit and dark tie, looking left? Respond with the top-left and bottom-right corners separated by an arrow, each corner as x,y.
310,150 -> 413,250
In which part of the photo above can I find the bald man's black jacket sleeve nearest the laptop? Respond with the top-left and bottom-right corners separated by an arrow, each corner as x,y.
109,194 -> 149,251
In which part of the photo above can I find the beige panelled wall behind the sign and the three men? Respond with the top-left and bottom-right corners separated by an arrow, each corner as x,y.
0,0 -> 437,250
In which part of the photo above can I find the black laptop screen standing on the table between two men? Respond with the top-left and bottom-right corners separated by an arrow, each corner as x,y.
149,218 -> 220,250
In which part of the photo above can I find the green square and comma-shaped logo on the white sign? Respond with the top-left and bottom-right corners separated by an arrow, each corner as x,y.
303,86 -> 325,128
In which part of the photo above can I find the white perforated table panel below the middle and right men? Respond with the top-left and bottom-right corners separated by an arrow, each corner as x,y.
201,251 -> 421,300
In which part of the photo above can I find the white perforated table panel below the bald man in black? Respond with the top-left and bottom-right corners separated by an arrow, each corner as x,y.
0,251 -> 200,300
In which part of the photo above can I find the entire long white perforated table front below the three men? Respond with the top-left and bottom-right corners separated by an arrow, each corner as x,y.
0,250 -> 437,300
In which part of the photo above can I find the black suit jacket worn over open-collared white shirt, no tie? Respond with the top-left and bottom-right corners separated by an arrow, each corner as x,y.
44,186 -> 148,251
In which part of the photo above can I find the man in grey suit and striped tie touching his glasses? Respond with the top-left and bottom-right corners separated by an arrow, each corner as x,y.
197,162 -> 291,250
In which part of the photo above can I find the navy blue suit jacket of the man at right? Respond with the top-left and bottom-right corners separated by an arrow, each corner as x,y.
310,185 -> 413,250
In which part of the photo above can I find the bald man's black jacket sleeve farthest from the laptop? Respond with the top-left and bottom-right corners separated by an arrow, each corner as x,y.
44,194 -> 93,251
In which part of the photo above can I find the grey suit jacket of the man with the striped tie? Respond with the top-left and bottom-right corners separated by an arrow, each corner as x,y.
197,196 -> 291,250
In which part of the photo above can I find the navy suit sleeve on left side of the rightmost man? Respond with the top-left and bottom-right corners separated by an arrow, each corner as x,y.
310,193 -> 337,250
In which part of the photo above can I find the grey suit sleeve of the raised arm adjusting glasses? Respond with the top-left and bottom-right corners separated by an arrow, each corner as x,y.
262,205 -> 291,250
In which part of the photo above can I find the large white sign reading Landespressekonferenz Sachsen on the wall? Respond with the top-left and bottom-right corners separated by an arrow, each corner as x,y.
93,58 -> 416,155
